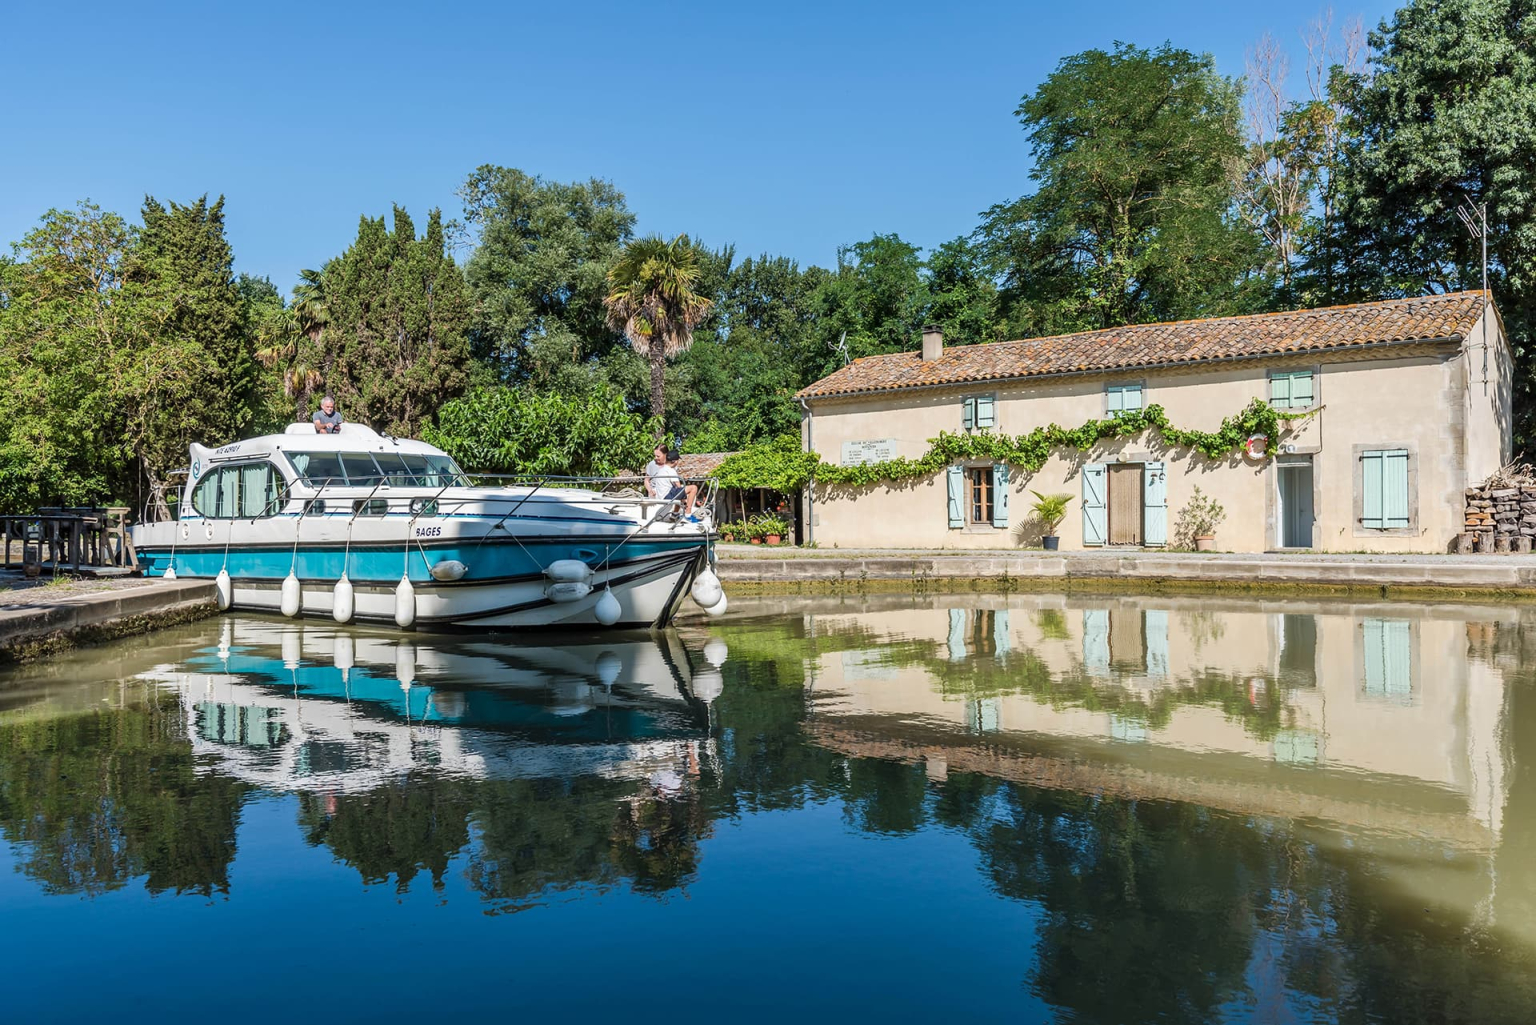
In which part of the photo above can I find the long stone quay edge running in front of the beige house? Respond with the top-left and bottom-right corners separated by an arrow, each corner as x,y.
717,544 -> 1536,598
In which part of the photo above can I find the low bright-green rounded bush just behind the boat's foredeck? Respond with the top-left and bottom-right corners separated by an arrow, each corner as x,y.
424,387 -> 660,476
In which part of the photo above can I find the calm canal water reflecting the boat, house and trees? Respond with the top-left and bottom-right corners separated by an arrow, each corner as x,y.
0,595 -> 1536,1023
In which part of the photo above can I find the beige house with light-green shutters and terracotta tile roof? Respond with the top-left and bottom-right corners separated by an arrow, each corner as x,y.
800,292 -> 1511,552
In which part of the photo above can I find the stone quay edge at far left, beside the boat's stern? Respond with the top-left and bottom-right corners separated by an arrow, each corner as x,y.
0,579 -> 218,661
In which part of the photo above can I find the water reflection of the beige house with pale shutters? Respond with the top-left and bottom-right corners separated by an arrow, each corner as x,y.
811,596 -> 1513,847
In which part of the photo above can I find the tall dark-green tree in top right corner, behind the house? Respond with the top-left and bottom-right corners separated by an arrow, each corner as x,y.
1339,0 -> 1536,438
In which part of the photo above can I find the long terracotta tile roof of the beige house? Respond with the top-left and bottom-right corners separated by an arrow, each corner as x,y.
800,292 -> 1484,398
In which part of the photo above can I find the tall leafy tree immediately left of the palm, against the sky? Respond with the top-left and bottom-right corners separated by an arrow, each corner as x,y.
459,164 -> 634,383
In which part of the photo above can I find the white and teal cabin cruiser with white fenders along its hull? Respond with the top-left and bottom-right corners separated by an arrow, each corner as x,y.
132,424 -> 725,630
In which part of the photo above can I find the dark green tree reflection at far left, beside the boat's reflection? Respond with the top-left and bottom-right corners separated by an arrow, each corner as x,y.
0,695 -> 246,894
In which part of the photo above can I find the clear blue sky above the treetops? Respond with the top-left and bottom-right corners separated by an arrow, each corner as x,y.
0,0 -> 1396,292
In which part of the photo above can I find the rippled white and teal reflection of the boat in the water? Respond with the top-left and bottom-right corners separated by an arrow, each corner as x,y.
140,619 -> 703,793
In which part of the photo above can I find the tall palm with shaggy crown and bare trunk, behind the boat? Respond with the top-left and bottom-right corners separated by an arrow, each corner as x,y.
604,235 -> 713,424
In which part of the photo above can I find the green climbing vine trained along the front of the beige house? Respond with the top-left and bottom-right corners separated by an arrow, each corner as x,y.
714,398 -> 1321,492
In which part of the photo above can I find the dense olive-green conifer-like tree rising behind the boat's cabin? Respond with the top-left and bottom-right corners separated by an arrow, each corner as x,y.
319,206 -> 473,436
